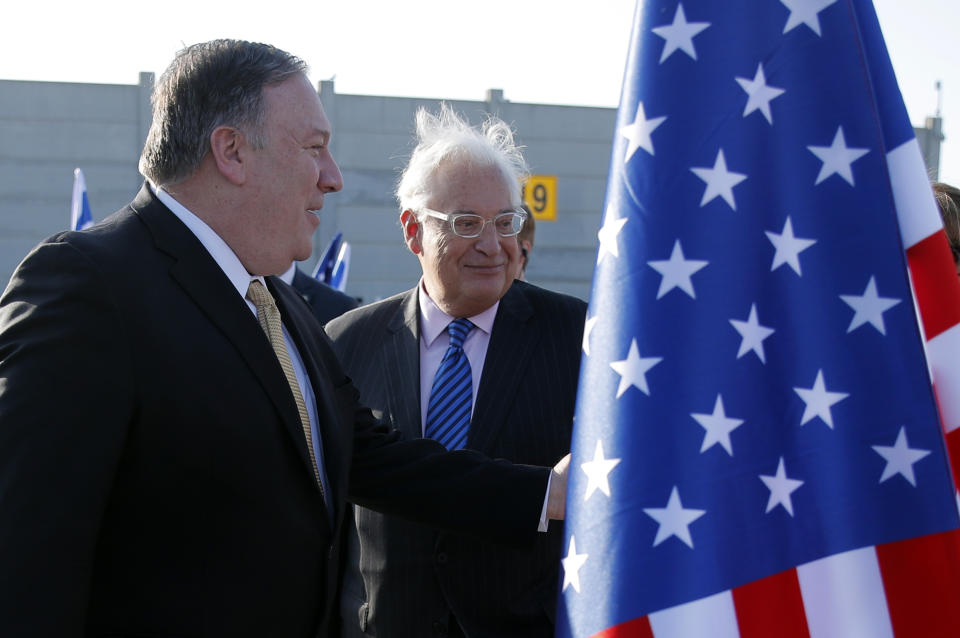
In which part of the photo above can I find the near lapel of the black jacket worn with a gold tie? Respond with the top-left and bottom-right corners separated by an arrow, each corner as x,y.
132,184 -> 326,504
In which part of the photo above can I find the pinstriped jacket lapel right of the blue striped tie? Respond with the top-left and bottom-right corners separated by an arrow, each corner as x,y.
467,284 -> 540,454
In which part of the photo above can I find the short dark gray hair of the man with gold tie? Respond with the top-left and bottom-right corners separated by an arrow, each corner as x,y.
140,40 -> 307,185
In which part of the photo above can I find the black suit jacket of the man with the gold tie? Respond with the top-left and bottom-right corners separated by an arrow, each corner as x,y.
0,186 -> 548,638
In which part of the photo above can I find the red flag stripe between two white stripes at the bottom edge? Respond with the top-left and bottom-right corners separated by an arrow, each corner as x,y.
733,569 -> 810,638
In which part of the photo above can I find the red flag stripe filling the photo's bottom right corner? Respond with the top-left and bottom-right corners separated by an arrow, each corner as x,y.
877,530 -> 960,638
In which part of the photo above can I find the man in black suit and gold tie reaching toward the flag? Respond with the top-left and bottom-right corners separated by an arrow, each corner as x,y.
0,40 -> 565,638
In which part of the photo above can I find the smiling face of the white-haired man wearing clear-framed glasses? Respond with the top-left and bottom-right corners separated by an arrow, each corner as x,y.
401,164 -> 520,317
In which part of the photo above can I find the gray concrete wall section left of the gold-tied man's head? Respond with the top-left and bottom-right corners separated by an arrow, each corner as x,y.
0,73 -> 153,285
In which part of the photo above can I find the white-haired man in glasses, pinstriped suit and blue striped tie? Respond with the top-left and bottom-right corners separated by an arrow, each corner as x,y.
326,108 -> 586,638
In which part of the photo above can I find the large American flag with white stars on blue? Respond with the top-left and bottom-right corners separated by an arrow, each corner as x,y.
557,0 -> 960,638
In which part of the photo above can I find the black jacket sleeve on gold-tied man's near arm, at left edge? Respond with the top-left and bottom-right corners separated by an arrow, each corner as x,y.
0,240 -> 133,636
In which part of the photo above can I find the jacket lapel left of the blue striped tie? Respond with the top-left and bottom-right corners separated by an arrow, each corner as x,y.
383,288 -> 423,439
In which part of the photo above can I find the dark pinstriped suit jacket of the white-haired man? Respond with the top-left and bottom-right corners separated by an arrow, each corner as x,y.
326,281 -> 586,638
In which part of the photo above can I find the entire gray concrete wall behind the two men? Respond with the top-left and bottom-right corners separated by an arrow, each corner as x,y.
0,73 -> 616,301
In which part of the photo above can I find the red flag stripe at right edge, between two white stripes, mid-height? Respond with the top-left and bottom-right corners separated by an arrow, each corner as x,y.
907,229 -> 960,339
